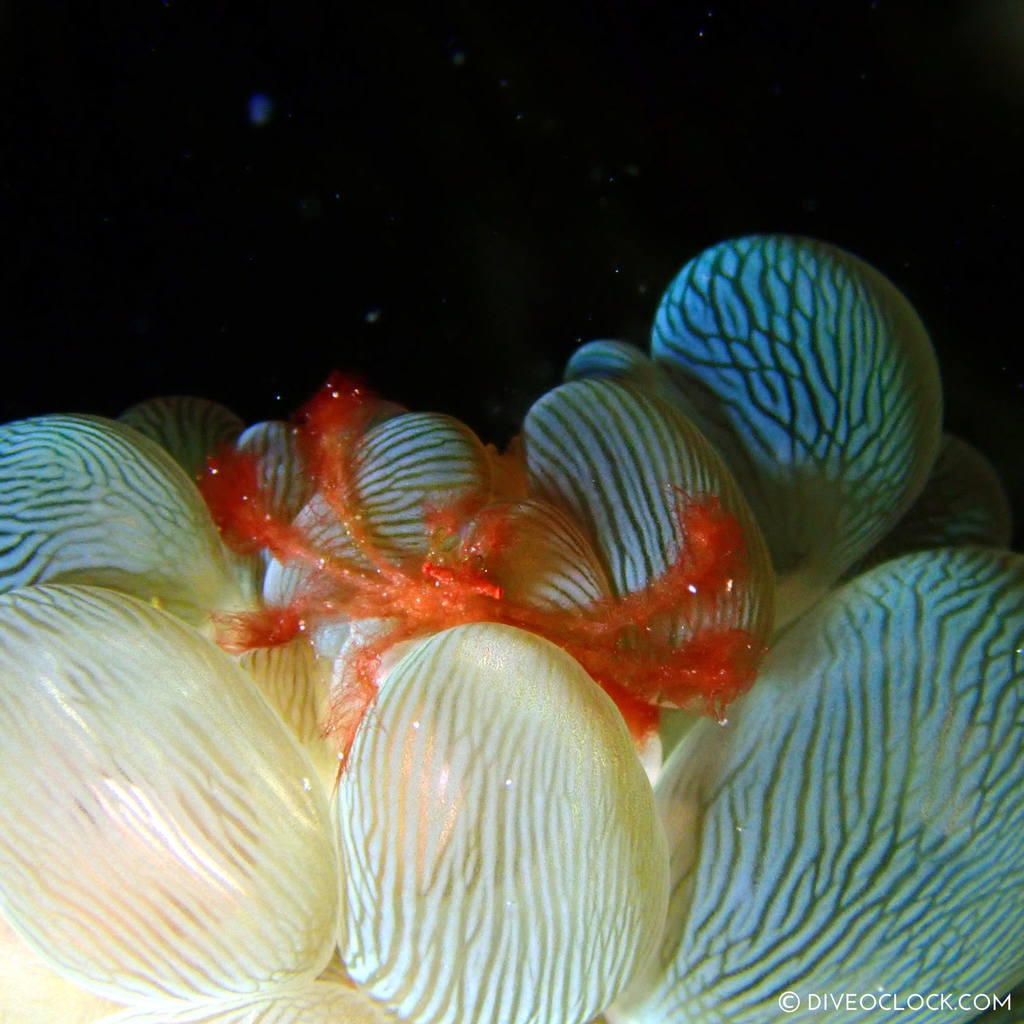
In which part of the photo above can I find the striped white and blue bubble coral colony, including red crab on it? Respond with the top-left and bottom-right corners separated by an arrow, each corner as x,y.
0,236 -> 1024,1024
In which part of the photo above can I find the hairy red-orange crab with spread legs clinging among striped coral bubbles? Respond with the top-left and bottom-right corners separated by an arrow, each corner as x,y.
201,374 -> 762,754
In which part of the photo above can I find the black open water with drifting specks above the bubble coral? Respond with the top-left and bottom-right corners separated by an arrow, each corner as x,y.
0,0 -> 1024,536
